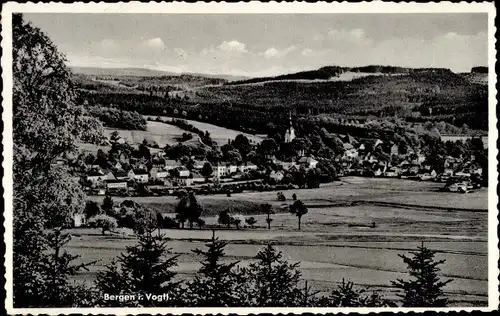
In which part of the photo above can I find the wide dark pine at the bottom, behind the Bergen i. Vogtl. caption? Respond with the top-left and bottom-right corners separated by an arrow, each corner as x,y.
95,231 -> 180,307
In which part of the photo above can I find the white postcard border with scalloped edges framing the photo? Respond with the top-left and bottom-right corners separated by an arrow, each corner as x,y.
1,1 -> 499,315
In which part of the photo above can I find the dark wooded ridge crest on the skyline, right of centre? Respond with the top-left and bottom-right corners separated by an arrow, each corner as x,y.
228,65 -> 452,85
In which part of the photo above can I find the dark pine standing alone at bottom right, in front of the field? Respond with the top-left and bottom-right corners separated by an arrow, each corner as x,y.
391,242 -> 452,307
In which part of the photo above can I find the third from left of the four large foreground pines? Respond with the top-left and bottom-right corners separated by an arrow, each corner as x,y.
245,244 -> 303,307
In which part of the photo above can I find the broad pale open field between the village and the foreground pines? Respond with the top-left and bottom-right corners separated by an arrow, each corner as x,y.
76,177 -> 488,306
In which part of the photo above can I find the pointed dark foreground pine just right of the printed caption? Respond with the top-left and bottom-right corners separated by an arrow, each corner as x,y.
183,232 -> 248,307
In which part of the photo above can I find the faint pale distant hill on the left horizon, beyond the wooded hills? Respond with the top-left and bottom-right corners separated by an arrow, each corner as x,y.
71,67 -> 248,81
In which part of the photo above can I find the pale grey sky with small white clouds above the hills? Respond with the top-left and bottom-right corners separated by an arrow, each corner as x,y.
24,13 -> 488,77
